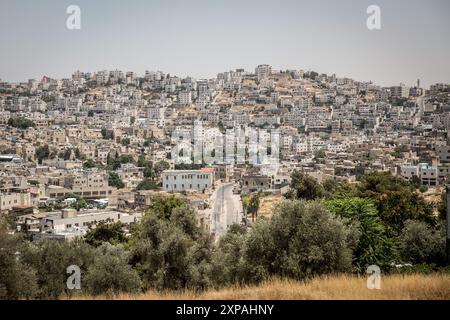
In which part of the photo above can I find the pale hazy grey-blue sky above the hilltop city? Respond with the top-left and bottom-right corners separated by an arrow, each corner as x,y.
0,0 -> 450,85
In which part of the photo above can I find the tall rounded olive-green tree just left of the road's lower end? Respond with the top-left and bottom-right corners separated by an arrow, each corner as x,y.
130,197 -> 212,290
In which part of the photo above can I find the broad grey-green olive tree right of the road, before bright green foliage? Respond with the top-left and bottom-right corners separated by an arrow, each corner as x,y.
246,200 -> 359,281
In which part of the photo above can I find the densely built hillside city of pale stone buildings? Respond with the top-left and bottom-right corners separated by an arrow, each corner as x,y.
0,65 -> 450,240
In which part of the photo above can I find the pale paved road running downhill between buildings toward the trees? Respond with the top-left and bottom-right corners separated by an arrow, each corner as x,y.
211,183 -> 242,239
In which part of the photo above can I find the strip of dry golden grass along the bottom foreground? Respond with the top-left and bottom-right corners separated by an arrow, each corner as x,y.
72,274 -> 450,300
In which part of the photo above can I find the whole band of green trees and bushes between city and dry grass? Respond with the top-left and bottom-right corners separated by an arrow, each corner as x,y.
0,171 -> 445,299
